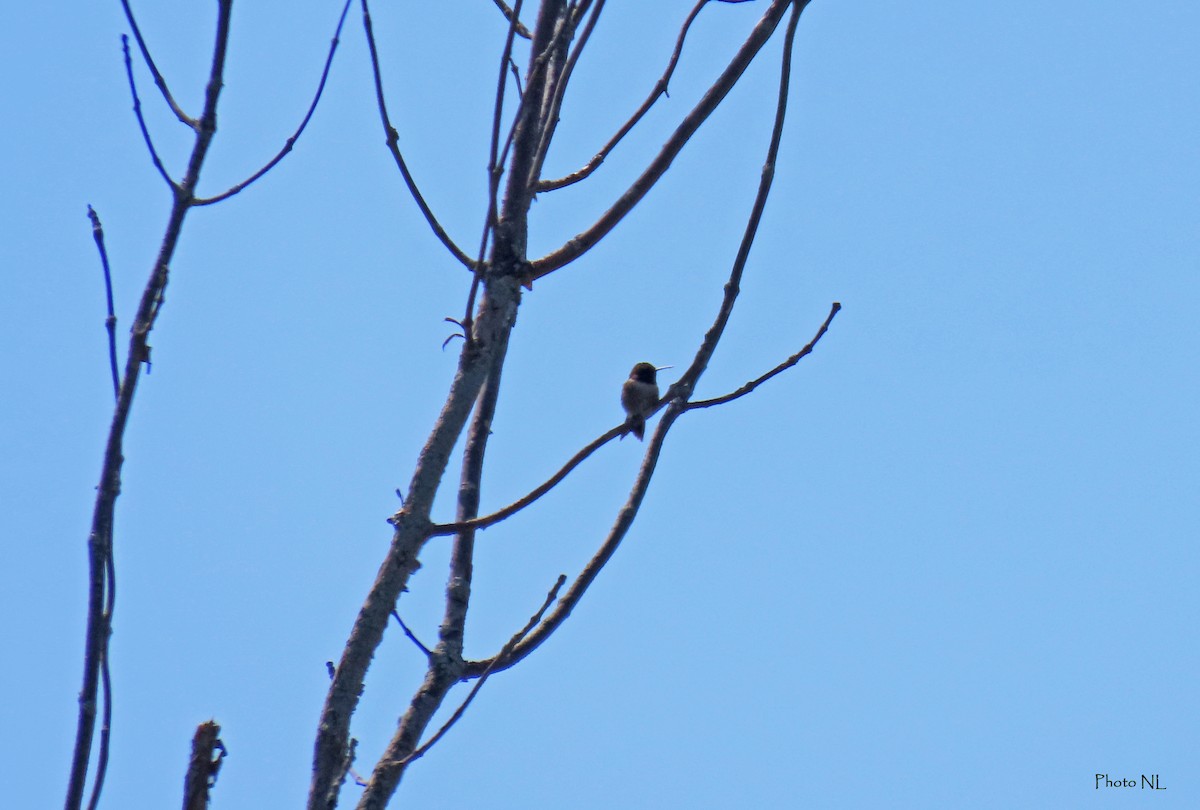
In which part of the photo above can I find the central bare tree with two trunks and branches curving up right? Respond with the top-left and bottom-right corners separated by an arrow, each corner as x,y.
308,0 -> 825,810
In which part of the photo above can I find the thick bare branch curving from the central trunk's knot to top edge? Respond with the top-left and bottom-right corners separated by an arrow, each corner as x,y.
530,0 -> 808,282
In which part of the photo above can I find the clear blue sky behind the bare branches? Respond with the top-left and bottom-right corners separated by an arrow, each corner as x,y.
0,0 -> 1200,810
